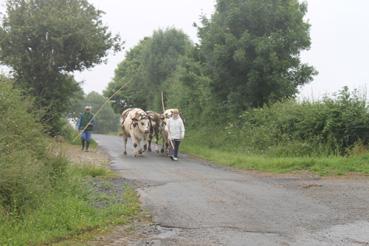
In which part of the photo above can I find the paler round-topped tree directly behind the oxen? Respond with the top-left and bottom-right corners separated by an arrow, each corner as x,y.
104,28 -> 193,111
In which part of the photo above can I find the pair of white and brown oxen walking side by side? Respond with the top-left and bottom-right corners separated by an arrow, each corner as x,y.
120,108 -> 173,157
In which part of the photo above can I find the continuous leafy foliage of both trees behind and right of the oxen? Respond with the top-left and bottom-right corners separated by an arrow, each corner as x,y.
104,0 -> 316,127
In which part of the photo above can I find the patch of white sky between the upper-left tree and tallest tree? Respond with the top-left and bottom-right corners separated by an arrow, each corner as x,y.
75,0 -> 215,93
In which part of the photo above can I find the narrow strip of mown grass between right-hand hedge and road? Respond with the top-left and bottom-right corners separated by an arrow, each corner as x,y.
181,137 -> 369,176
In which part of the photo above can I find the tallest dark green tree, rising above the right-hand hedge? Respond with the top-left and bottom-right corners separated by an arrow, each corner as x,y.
199,0 -> 316,115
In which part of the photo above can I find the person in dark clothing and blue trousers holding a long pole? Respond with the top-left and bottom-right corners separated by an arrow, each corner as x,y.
77,106 -> 95,152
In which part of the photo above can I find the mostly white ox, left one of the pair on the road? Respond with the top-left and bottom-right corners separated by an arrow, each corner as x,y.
120,108 -> 150,156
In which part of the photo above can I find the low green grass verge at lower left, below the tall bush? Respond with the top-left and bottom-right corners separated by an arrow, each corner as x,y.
0,162 -> 140,245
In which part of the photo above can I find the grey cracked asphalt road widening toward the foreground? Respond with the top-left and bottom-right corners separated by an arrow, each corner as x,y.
94,135 -> 369,246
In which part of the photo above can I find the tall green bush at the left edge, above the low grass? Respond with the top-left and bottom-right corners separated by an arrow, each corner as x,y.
0,77 -> 62,214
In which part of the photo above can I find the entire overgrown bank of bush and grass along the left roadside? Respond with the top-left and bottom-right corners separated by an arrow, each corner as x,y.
0,80 -> 140,245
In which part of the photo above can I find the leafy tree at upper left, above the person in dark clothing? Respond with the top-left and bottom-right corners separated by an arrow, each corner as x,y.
0,0 -> 121,135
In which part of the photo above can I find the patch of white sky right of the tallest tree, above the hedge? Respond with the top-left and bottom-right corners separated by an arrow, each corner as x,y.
300,0 -> 369,100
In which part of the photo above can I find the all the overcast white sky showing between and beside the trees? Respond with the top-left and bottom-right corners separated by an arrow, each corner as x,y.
0,0 -> 369,100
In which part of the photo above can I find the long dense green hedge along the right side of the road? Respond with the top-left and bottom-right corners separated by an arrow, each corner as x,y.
191,88 -> 369,156
